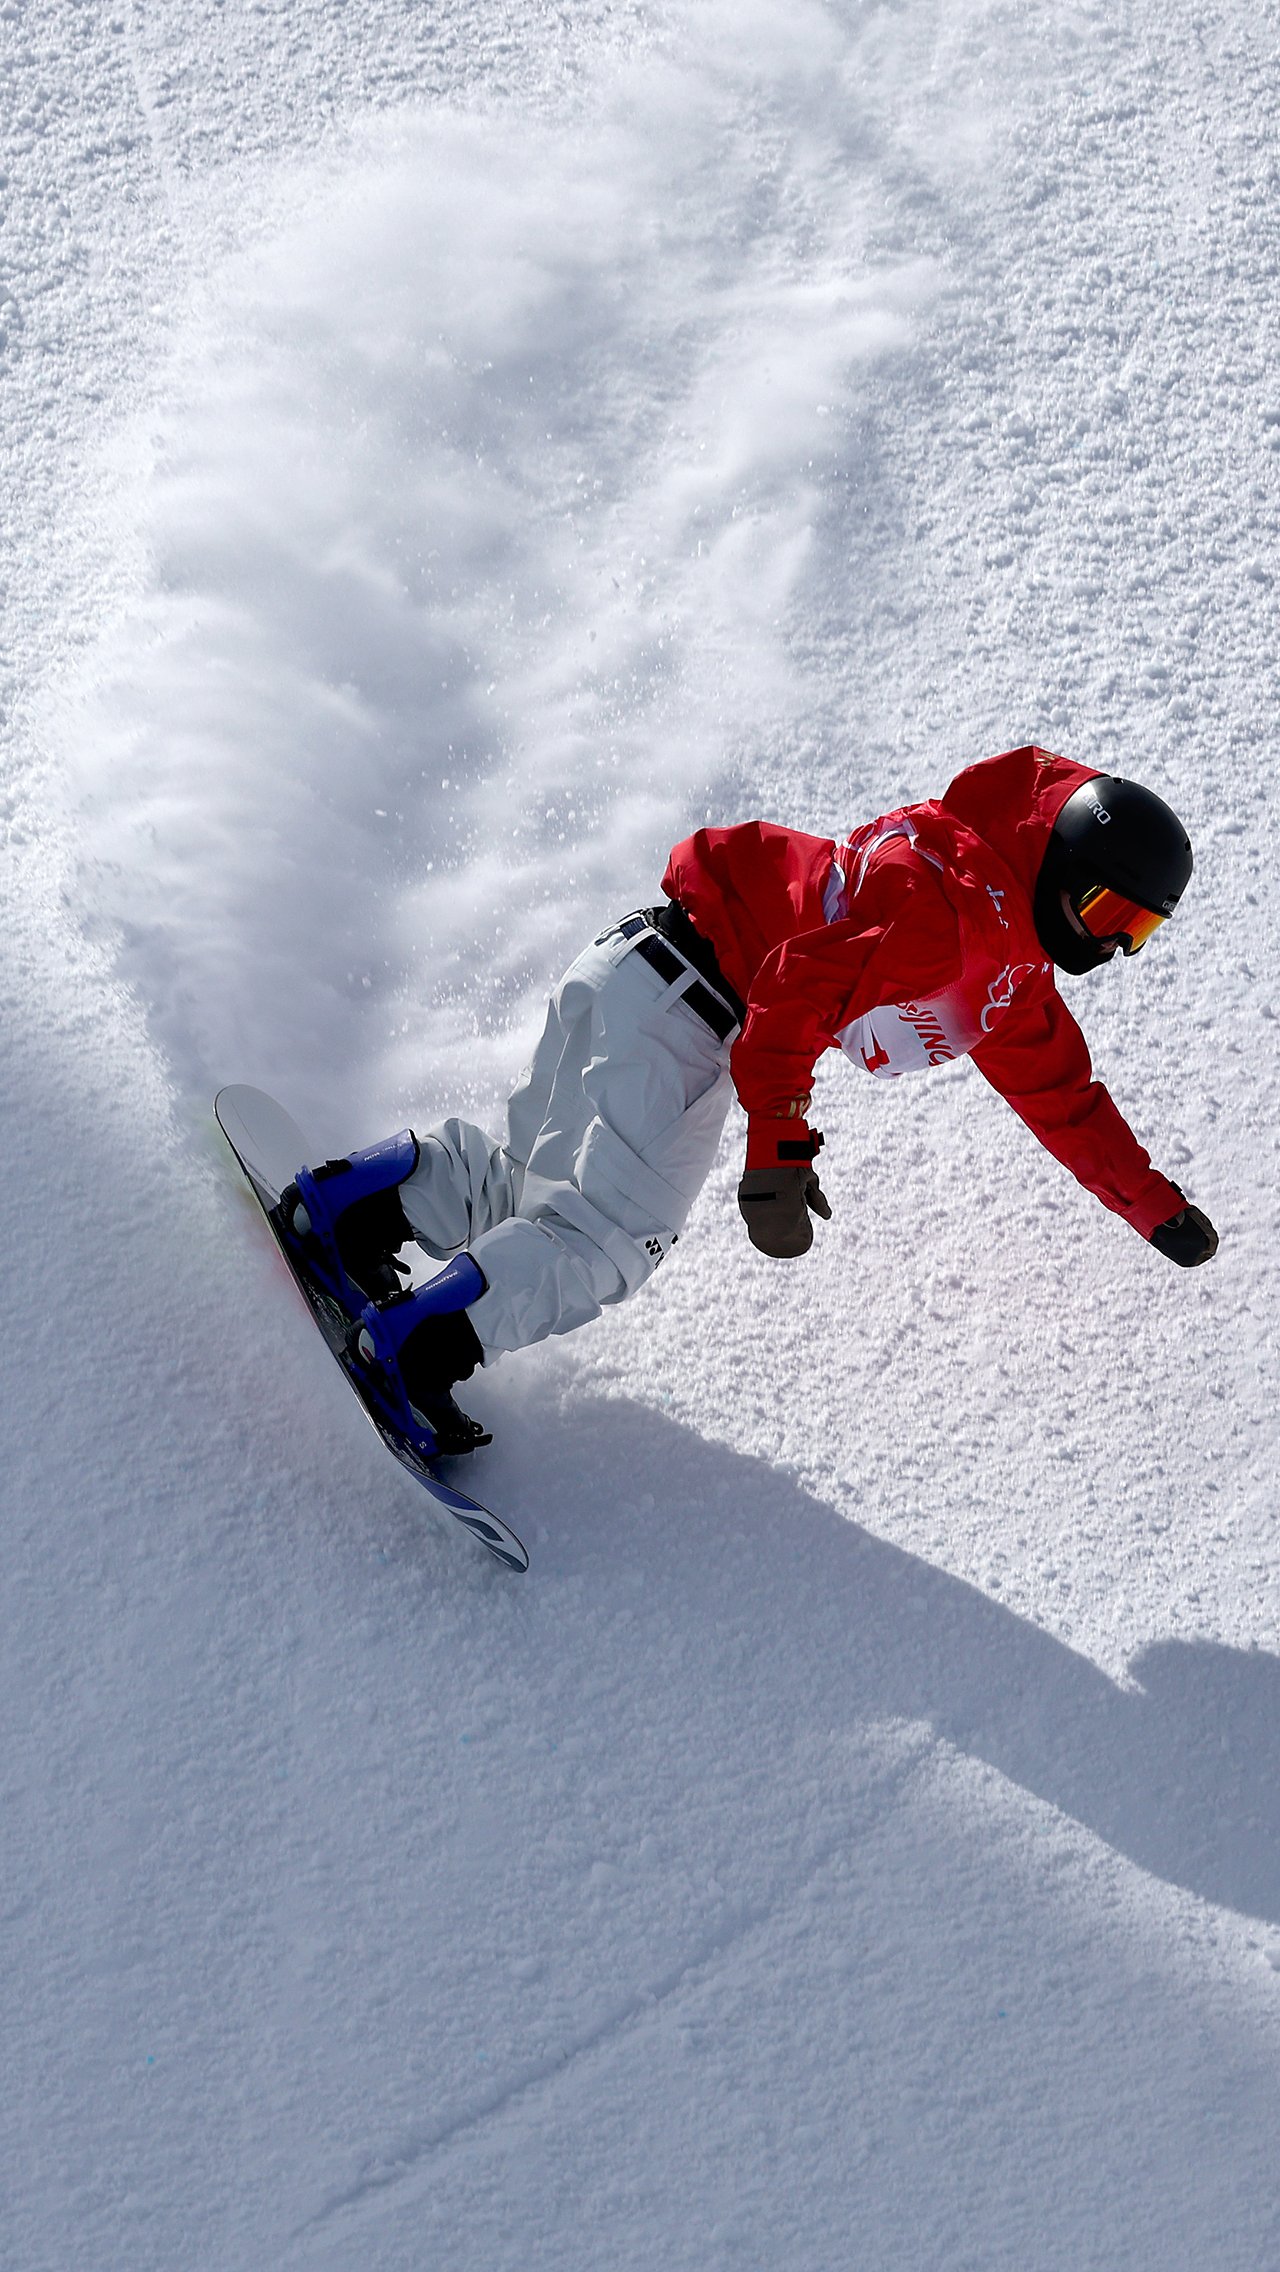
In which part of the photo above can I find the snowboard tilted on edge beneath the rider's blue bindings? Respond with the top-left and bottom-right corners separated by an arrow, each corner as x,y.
214,1086 -> 530,1570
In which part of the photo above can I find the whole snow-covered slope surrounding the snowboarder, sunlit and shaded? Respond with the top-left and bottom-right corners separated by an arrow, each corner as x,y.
0,0 -> 1280,2272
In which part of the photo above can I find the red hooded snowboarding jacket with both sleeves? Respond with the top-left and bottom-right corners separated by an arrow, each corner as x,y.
662,747 -> 1185,1238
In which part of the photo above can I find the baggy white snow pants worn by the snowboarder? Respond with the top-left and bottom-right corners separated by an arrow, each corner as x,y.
400,932 -> 734,1363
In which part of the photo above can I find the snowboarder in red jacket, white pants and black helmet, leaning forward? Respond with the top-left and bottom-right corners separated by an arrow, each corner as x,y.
280,747 -> 1219,1450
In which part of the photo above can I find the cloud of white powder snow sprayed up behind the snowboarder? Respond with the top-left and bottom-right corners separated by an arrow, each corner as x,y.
65,5 -> 954,1141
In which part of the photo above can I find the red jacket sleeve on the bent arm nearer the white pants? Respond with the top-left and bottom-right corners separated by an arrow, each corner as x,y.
730,845 -> 962,1118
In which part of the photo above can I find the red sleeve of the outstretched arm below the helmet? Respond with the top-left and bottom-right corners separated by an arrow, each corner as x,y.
973,986 -> 1185,1238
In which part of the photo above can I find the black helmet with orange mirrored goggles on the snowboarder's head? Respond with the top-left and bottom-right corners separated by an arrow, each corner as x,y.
1034,772 -> 1191,972
